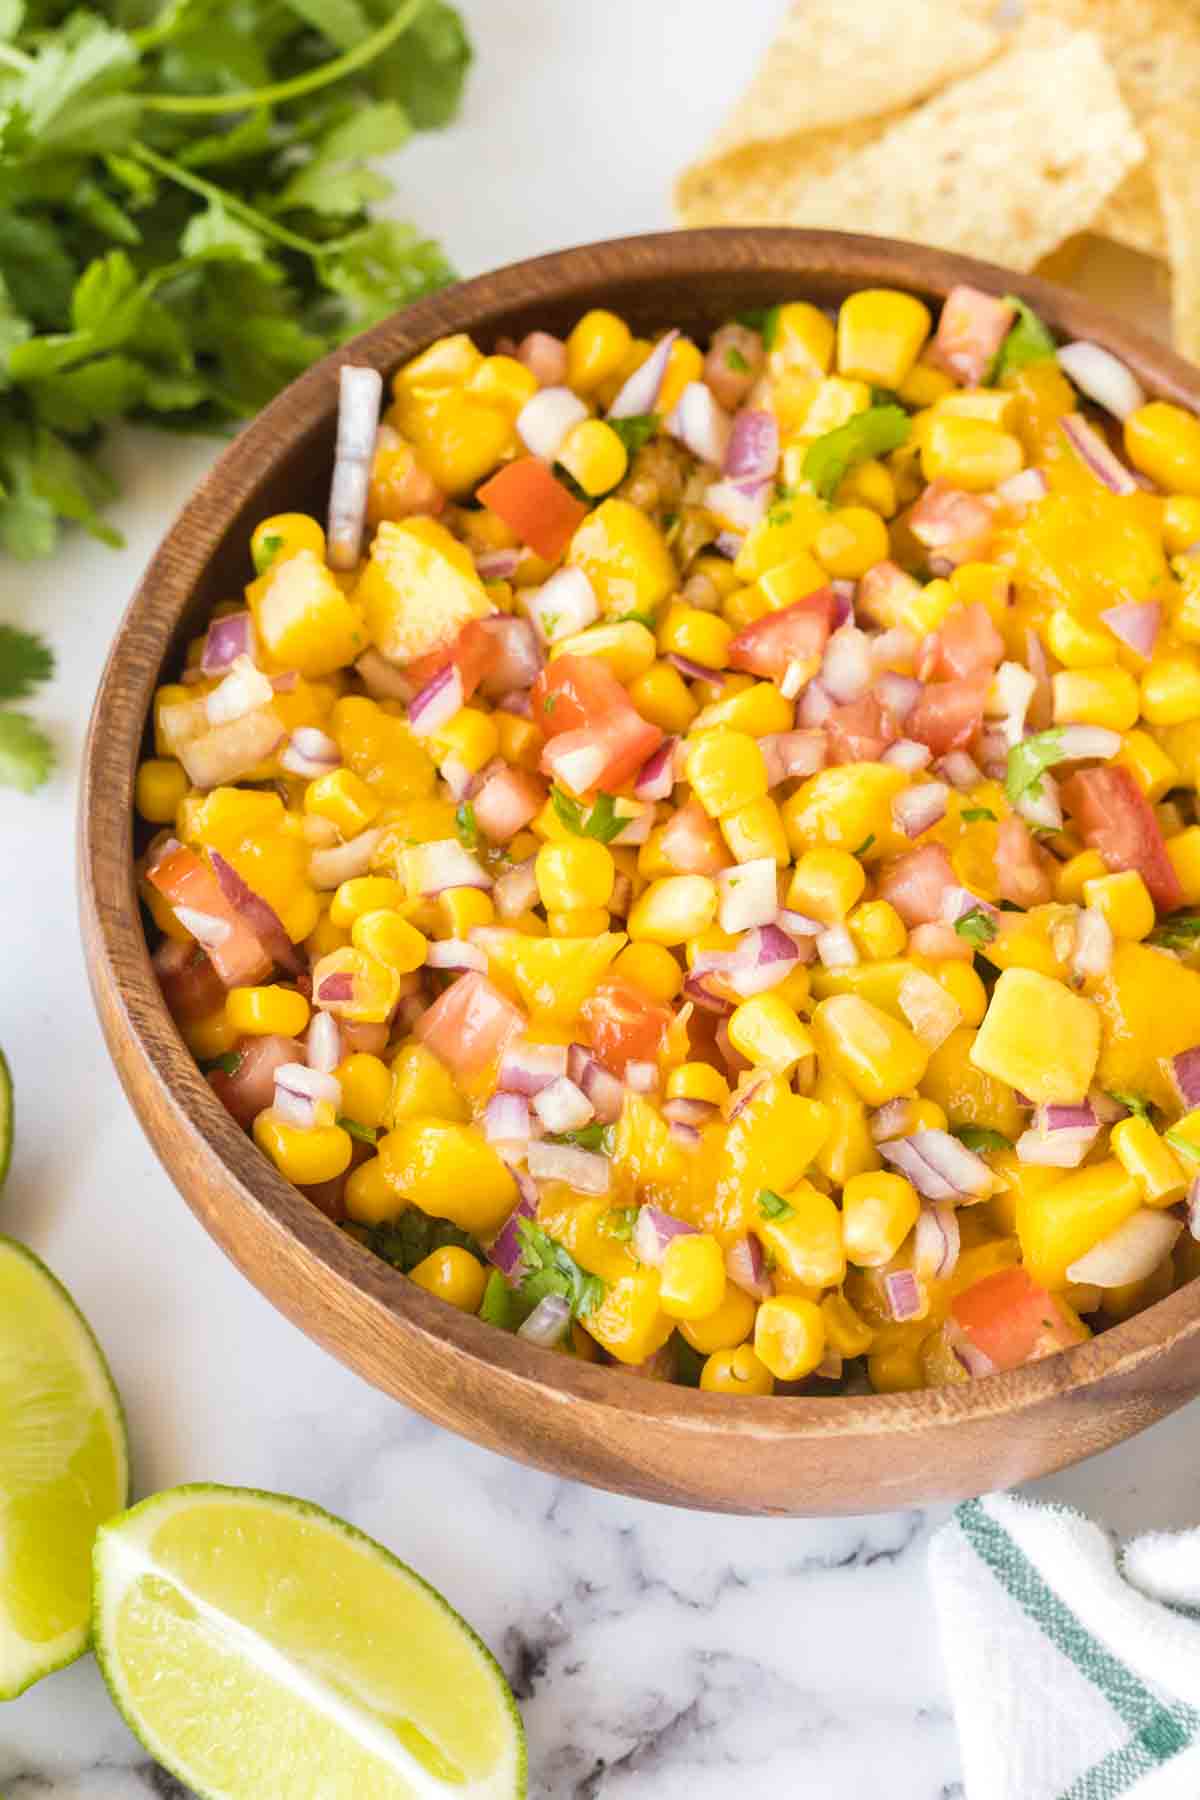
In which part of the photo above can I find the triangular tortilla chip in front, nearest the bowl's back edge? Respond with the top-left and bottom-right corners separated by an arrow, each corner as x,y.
719,32 -> 1146,268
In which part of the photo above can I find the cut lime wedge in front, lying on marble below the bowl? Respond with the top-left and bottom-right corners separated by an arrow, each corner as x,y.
94,1487 -> 525,1800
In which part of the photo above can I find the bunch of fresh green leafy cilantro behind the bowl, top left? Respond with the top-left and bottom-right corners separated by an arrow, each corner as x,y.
0,0 -> 470,556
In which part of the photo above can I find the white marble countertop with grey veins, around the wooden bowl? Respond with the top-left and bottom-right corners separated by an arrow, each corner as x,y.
0,0 -> 1200,1800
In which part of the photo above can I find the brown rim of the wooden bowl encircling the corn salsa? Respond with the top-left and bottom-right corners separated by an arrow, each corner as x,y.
79,227 -> 1200,1447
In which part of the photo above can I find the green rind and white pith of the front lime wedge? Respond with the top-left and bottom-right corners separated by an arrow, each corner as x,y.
92,1483 -> 527,1800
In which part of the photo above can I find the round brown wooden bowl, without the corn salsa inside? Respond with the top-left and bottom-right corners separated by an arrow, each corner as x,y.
79,229 -> 1200,1514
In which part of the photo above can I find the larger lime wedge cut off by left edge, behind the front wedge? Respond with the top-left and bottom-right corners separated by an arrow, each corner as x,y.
0,1237 -> 130,1699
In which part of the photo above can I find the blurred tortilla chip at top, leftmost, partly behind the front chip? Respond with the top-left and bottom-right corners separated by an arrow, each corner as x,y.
675,0 -> 1004,225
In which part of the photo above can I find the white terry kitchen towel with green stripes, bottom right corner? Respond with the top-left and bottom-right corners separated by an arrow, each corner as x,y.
930,1494 -> 1200,1800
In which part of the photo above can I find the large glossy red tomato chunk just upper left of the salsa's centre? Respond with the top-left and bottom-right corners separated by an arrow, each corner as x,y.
533,657 -> 662,794
